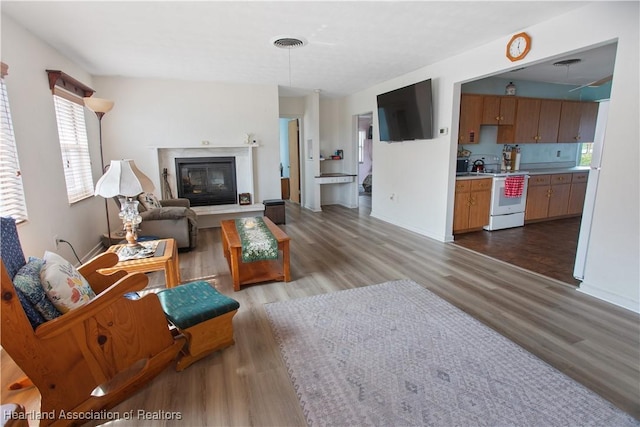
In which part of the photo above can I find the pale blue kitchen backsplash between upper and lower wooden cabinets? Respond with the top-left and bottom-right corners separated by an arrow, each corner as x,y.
464,126 -> 581,170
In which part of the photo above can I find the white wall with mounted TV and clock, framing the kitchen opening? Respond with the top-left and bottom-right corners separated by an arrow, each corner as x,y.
342,2 -> 640,311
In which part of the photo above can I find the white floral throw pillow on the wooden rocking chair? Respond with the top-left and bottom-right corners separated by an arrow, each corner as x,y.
40,251 -> 96,313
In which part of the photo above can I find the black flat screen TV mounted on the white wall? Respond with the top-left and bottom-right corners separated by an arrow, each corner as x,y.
378,79 -> 433,142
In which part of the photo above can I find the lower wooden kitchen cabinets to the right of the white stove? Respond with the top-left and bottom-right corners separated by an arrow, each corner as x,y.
524,173 -> 586,221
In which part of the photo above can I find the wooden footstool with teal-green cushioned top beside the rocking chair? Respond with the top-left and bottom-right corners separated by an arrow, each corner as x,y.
157,281 -> 240,371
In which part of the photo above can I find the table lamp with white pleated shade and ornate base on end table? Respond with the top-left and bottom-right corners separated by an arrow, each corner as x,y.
95,160 -> 154,256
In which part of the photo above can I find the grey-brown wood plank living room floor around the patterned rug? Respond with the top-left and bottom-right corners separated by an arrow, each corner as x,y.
2,202 -> 640,426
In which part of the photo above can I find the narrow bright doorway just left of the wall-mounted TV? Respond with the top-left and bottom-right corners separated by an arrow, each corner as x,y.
356,112 -> 373,212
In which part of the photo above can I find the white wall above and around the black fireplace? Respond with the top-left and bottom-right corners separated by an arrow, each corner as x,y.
94,77 -> 280,212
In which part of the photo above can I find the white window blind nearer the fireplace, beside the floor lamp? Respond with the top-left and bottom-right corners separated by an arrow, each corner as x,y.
53,88 -> 93,203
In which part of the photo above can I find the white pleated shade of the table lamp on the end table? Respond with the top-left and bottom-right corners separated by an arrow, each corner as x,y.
95,159 -> 155,197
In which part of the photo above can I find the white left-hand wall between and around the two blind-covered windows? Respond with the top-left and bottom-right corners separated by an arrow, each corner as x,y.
2,15 -> 107,262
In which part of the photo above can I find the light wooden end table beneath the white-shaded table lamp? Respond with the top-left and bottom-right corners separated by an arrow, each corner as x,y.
99,239 -> 180,288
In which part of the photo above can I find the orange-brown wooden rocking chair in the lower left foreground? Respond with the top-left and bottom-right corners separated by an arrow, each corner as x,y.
0,218 -> 185,426
